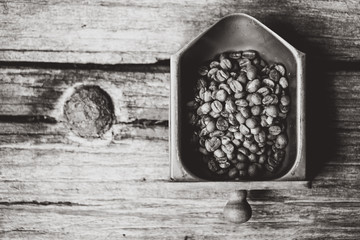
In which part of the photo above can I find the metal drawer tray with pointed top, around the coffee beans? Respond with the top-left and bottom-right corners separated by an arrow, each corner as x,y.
170,14 -> 306,181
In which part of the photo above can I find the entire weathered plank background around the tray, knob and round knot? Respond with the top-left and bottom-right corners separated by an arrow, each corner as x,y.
0,0 -> 360,240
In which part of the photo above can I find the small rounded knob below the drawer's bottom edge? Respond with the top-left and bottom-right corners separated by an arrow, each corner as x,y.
224,190 -> 252,223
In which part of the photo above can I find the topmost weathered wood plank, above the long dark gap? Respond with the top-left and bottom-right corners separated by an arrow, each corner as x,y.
0,0 -> 360,64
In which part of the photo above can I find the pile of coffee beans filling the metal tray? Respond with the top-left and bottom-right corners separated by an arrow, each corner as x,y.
187,50 -> 290,180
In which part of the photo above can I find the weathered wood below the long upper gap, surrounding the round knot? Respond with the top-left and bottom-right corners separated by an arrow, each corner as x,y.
0,66 -> 360,240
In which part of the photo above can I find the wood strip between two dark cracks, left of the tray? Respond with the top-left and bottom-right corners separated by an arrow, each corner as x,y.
0,67 -> 170,122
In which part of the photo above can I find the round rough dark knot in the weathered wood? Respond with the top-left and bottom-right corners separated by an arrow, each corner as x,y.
64,86 -> 114,138
